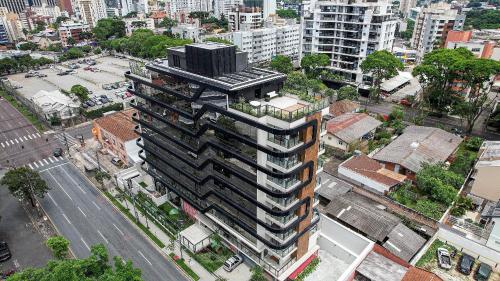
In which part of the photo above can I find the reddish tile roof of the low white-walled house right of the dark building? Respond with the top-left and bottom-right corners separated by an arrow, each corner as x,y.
341,154 -> 406,187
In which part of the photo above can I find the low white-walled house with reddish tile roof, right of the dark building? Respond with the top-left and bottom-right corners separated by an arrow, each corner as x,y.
338,154 -> 406,194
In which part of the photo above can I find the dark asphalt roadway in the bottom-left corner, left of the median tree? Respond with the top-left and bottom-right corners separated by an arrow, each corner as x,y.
0,172 -> 52,272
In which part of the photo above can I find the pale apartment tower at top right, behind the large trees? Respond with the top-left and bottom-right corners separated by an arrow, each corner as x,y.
411,3 -> 465,60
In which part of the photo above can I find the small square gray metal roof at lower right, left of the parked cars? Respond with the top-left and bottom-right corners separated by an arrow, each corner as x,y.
383,223 -> 426,262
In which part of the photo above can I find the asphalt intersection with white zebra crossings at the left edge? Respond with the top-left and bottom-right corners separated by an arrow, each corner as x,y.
0,99 -> 60,169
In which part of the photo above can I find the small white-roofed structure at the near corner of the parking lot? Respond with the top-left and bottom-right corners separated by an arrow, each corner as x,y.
31,90 -> 80,122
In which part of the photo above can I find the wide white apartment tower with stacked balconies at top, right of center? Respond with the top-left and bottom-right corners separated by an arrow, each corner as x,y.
301,0 -> 396,84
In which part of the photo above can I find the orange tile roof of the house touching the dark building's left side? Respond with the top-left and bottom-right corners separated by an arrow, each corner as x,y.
94,108 -> 139,141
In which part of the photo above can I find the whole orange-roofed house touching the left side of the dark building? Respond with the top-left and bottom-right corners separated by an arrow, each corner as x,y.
92,109 -> 141,166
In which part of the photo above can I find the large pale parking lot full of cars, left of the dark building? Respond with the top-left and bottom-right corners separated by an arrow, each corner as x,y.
7,56 -> 135,109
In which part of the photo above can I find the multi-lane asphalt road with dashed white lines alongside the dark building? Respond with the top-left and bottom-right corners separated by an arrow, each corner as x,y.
35,161 -> 188,281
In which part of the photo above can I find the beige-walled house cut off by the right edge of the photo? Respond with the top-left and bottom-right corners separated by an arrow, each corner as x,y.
469,141 -> 500,202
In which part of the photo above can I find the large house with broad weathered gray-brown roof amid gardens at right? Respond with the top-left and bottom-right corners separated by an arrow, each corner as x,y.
373,126 -> 462,180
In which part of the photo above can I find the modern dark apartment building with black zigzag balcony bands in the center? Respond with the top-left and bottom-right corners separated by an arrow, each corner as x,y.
126,43 -> 330,280
